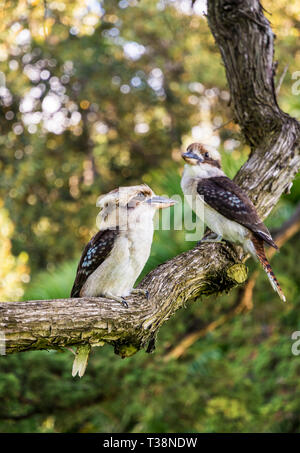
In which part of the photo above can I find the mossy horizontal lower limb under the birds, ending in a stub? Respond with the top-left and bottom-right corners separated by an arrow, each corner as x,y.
0,244 -> 247,357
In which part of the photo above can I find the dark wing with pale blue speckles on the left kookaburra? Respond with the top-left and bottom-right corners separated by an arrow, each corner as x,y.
71,228 -> 119,297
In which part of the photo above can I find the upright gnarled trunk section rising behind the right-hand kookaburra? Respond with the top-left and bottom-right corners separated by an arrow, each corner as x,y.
208,0 -> 300,218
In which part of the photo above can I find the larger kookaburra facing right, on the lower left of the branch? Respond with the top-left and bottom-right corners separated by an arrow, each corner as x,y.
71,184 -> 175,377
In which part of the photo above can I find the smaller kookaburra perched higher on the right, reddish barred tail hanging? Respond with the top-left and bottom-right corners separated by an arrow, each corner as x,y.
181,143 -> 286,301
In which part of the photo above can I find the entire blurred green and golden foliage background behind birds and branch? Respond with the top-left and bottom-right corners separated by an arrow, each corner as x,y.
0,0 -> 300,433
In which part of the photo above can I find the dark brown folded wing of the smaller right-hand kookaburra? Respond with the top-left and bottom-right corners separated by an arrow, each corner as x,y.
197,176 -> 278,249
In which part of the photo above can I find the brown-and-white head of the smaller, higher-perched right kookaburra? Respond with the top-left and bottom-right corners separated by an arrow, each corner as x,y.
182,143 -> 221,169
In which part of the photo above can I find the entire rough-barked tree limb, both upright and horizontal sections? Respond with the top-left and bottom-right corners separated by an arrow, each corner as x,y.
0,0 -> 300,357
